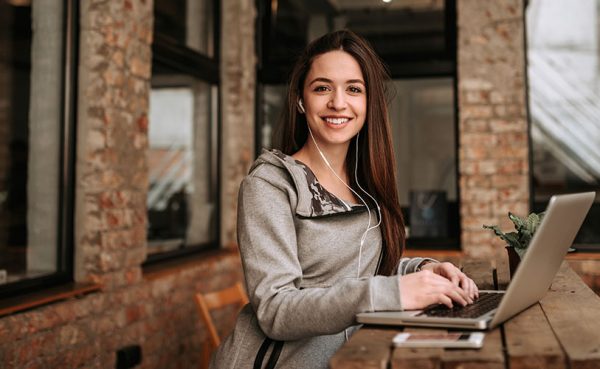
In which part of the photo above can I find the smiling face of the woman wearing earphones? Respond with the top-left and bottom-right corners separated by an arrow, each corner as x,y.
303,50 -> 367,146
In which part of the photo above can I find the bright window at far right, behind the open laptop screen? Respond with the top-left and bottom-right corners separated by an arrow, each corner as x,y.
526,0 -> 600,251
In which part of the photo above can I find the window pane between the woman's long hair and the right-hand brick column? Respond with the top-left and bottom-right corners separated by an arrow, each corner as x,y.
390,77 -> 460,248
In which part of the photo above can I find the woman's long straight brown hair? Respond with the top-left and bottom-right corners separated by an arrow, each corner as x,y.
273,30 -> 405,275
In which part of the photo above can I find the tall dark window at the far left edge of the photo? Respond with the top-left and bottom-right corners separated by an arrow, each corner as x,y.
0,0 -> 75,296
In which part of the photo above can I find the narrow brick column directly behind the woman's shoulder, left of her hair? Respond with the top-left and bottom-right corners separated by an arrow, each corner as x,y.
221,0 -> 256,248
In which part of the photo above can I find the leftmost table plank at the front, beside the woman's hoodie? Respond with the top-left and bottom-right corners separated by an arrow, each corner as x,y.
329,326 -> 402,369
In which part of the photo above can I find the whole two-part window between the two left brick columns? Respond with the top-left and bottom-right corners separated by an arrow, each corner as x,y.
147,0 -> 219,262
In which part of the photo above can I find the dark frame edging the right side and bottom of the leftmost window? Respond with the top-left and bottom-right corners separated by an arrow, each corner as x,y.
0,0 -> 80,299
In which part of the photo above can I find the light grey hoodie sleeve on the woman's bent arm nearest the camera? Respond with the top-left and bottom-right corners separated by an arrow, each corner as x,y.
238,176 -> 401,340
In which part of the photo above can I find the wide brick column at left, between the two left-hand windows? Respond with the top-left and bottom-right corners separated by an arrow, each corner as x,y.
75,0 -> 153,288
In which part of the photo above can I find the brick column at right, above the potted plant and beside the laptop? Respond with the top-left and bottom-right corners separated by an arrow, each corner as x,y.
457,0 -> 529,256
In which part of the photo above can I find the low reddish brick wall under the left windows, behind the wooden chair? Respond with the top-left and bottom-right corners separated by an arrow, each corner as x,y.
0,254 -> 241,369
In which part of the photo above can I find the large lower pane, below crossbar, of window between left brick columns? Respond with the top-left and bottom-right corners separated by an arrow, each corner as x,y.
147,73 -> 217,254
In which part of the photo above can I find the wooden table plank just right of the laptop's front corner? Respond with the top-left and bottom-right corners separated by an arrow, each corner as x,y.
504,304 -> 567,369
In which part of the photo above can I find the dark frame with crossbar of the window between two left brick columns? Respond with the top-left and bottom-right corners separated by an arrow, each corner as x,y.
142,0 -> 222,267
